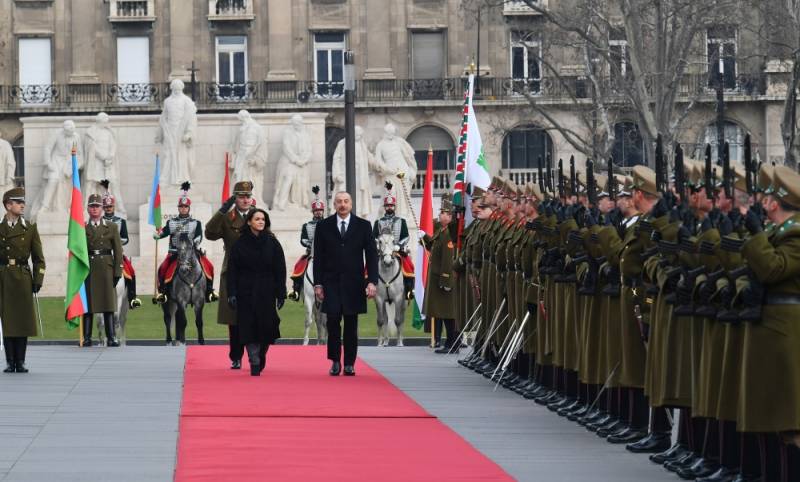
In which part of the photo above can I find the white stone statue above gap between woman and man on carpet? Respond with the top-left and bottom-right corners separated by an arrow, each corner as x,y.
272,114 -> 311,211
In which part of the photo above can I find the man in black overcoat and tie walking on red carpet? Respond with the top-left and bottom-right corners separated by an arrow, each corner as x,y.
314,192 -> 378,376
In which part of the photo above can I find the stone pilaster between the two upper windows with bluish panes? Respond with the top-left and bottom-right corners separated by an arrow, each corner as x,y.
267,0 -> 297,80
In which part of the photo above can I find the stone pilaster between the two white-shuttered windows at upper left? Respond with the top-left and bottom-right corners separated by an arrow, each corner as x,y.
69,0 -> 100,84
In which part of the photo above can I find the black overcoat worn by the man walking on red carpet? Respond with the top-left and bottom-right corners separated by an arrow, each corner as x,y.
314,214 -> 378,315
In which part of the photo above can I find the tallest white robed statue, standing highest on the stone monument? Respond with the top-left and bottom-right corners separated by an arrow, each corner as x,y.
156,79 -> 197,186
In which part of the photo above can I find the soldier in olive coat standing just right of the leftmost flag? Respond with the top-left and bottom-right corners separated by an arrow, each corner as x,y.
82,194 -> 122,347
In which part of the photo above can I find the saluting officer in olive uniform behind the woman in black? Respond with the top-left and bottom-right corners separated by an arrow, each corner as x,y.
206,181 -> 254,370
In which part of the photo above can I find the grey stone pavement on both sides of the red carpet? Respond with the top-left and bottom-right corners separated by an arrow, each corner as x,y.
0,346 -> 676,482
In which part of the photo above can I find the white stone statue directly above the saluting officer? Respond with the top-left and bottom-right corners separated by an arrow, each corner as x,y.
229,110 -> 267,206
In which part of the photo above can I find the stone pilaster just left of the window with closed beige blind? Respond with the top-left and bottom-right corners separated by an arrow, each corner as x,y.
364,0 -> 395,79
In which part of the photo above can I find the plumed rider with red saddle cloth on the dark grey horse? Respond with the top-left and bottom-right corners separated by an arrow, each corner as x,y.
153,182 -> 219,303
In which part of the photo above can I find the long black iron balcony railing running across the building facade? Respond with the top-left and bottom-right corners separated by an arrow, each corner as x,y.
0,74 -> 766,111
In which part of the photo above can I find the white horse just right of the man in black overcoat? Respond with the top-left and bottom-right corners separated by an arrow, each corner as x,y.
375,233 -> 406,346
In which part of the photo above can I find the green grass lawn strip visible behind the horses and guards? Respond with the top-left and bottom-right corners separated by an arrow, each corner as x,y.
34,295 -> 430,340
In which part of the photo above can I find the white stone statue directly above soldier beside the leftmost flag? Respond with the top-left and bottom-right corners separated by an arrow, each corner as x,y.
83,112 -> 126,216
